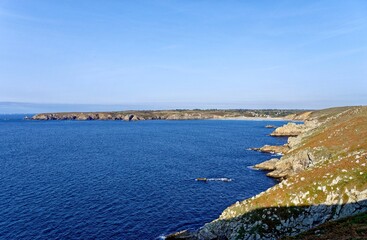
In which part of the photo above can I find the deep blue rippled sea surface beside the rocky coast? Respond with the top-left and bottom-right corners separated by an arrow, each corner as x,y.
0,115 -> 286,240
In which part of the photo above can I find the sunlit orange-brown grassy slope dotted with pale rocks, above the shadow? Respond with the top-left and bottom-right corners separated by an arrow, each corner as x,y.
213,107 -> 367,238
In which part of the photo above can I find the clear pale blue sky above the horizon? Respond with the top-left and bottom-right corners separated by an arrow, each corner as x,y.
0,0 -> 367,112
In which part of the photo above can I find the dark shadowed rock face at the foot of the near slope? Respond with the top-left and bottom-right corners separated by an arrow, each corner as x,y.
198,197 -> 367,240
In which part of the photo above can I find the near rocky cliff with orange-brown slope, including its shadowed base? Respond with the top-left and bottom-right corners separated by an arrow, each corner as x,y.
168,107 -> 367,239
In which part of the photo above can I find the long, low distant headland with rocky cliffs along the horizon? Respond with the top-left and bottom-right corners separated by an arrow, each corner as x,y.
32,109 -> 304,121
